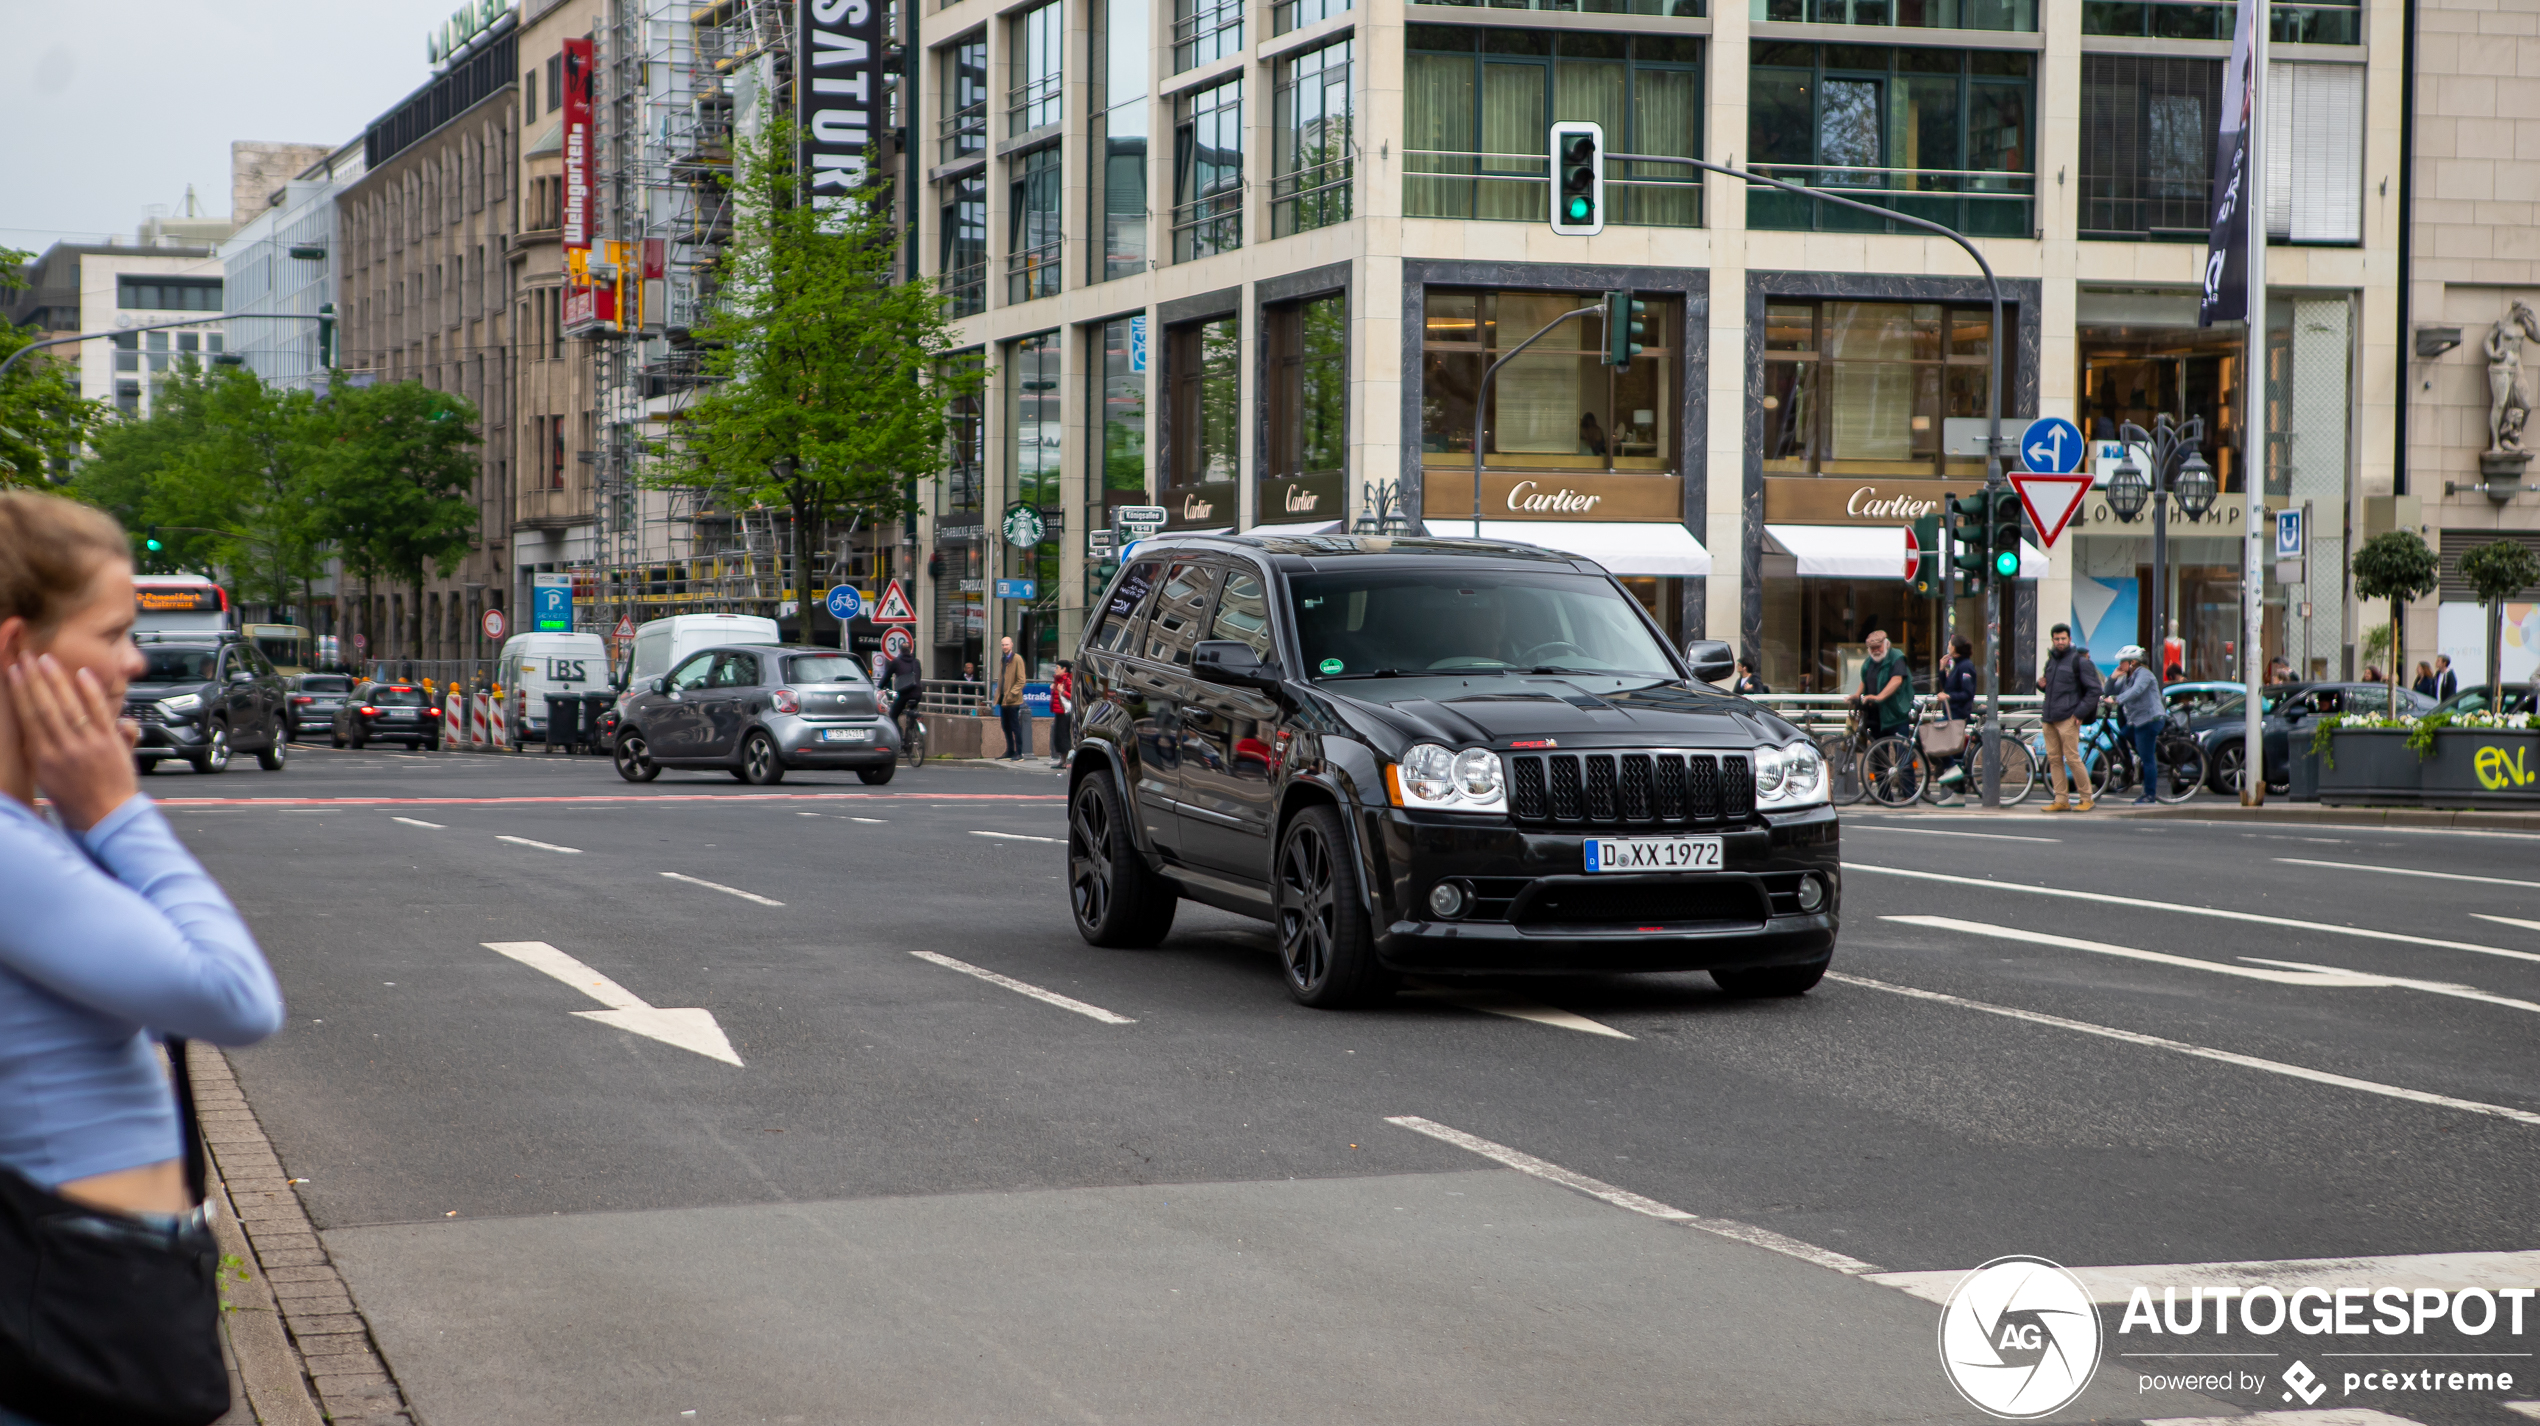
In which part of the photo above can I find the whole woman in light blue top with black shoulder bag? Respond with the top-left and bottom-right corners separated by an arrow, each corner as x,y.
0,491 -> 282,1426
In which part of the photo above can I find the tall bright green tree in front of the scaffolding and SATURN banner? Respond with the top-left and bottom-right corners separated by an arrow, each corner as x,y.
648,125 -> 986,630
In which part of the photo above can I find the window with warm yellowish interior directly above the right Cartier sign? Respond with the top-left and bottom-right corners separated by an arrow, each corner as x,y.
1763,300 -> 2012,475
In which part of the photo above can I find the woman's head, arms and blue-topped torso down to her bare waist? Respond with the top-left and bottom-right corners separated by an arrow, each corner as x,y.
0,491 -> 282,1215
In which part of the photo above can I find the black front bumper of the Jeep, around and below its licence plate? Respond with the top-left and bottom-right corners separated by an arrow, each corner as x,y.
1367,806 -> 1844,974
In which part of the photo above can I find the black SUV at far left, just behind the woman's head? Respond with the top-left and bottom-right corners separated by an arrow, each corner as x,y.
124,635 -> 290,773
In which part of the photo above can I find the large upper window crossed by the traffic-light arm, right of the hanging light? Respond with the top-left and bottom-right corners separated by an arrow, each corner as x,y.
1748,41 -> 2037,236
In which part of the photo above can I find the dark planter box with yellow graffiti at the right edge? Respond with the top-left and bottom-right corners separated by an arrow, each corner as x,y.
2311,712 -> 2540,808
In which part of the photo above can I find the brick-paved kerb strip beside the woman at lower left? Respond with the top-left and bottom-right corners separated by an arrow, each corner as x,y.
185,1042 -> 414,1426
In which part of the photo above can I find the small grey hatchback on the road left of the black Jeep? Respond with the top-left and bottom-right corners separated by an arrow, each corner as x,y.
610,643 -> 899,785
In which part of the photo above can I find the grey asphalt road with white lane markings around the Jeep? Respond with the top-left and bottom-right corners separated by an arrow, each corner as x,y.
168,747 -> 2540,1426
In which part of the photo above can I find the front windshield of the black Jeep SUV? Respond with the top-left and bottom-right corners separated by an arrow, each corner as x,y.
1288,562 -> 1676,679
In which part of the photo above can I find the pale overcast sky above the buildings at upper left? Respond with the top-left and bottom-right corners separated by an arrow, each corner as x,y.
0,0 -> 457,252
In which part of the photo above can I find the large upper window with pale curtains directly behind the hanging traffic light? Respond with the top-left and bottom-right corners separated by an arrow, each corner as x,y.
1402,25 -> 1706,226
